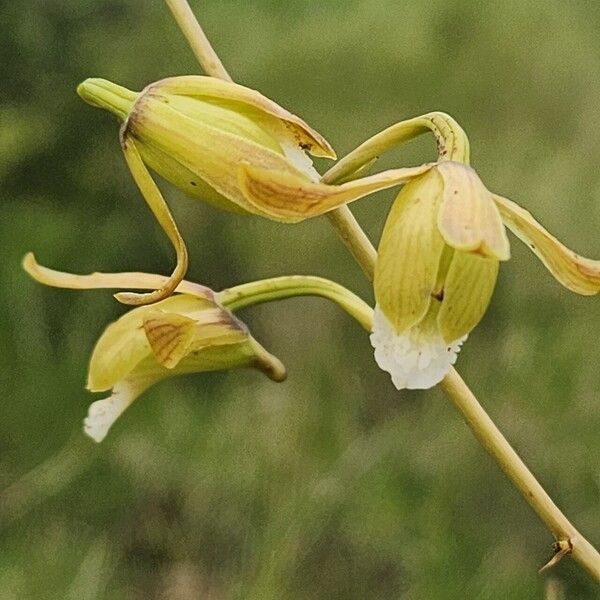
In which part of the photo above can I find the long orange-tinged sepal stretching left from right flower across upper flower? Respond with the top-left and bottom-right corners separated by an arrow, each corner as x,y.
239,165 -> 431,223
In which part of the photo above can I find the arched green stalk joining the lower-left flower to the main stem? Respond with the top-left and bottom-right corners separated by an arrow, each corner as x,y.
217,275 -> 373,332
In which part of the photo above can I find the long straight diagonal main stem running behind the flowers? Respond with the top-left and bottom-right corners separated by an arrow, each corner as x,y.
166,0 -> 600,582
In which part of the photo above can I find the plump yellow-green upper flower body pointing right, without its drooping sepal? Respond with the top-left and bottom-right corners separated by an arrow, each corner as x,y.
77,75 -> 335,214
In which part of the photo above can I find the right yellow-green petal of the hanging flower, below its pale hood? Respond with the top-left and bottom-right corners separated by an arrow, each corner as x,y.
437,250 -> 500,342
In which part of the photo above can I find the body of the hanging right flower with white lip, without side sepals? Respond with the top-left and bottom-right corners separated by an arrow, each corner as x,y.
371,162 -> 509,389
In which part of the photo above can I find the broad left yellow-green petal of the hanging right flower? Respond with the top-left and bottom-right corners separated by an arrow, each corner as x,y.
374,170 -> 445,333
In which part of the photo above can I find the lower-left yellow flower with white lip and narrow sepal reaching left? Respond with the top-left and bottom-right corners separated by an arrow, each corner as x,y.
23,254 -> 286,442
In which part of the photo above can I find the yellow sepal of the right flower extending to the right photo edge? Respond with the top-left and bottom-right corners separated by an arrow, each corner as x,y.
493,196 -> 600,296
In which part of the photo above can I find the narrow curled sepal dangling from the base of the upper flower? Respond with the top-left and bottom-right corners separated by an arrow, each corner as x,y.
115,136 -> 188,306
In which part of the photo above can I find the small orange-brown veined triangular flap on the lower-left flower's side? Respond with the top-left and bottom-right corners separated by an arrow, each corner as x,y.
143,311 -> 196,369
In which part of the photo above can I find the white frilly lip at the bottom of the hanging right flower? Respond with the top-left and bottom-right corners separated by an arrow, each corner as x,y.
371,306 -> 467,390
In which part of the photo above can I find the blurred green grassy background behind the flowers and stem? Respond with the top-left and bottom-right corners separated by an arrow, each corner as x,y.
0,0 -> 600,600
